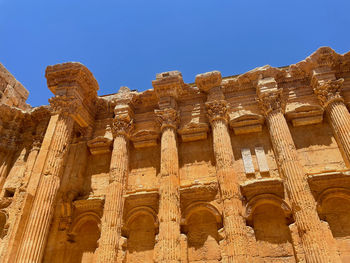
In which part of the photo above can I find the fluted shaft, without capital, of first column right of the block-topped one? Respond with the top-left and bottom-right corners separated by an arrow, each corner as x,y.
96,135 -> 128,263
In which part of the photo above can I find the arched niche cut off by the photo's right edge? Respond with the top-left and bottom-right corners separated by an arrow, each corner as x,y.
317,188 -> 350,262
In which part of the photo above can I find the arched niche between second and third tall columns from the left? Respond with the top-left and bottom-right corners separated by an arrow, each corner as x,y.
123,206 -> 158,263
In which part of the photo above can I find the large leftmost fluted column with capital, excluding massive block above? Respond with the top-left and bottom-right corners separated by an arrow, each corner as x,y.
16,97 -> 76,263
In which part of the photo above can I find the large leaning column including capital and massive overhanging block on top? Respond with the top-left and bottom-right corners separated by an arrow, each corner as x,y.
15,63 -> 98,263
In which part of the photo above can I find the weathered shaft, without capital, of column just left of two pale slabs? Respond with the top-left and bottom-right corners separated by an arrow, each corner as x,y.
212,119 -> 251,262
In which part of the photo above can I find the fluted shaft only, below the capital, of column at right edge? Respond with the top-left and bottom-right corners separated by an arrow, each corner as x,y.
326,100 -> 350,167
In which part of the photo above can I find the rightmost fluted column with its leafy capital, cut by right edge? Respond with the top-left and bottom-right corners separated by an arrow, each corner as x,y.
314,79 -> 350,167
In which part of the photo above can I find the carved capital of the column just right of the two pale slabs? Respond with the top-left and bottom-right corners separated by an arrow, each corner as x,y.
257,89 -> 286,116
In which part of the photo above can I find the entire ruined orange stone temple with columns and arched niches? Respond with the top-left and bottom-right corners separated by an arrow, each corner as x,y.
0,47 -> 350,263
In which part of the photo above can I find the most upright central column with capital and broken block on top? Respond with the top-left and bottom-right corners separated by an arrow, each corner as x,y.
153,71 -> 183,263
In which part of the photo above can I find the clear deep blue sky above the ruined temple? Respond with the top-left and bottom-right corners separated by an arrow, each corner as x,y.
0,0 -> 350,106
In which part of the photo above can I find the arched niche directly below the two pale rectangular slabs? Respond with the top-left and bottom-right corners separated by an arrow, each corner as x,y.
246,194 -> 296,262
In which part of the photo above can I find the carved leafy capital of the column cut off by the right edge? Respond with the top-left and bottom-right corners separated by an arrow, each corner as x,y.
314,79 -> 344,108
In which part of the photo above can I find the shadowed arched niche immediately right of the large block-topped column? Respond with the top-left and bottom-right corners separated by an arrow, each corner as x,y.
66,212 -> 100,263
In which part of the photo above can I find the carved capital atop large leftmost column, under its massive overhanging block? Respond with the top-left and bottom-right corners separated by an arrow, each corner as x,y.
49,96 -> 81,115
